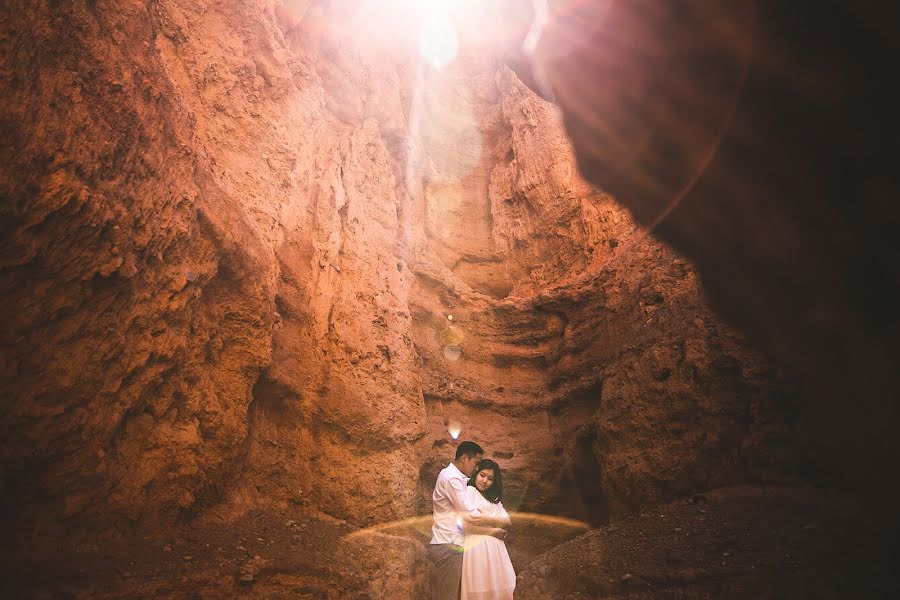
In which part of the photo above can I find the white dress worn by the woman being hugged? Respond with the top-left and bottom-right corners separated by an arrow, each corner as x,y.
460,485 -> 516,600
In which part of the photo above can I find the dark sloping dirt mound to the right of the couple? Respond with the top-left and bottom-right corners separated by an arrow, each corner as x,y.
516,486 -> 895,600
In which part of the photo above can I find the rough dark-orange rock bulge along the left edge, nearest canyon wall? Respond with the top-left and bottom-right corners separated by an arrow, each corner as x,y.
0,4 -> 276,536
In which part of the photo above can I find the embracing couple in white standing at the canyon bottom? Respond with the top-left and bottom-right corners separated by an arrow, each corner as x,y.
428,442 -> 516,600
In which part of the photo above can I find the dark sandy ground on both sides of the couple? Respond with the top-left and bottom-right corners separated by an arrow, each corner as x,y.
2,487 -> 896,600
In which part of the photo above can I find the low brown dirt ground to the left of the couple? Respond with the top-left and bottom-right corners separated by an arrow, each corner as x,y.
0,507 -> 426,600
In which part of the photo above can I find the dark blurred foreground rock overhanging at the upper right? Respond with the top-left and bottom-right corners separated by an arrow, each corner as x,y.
516,0 -> 900,496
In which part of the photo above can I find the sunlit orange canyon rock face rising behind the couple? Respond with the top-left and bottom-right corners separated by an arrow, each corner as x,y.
0,0 -> 805,560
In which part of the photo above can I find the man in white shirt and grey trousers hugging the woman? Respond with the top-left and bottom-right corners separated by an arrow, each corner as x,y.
428,442 -> 506,600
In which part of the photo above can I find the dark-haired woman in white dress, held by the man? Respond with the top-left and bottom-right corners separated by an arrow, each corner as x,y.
460,459 -> 516,600
